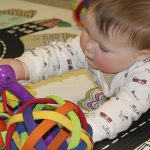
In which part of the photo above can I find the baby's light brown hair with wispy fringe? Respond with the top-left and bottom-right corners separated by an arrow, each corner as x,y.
90,0 -> 150,49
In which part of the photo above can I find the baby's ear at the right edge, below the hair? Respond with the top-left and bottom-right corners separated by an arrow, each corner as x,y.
136,49 -> 150,61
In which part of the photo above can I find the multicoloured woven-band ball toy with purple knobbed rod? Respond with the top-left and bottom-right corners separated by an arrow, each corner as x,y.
0,66 -> 93,150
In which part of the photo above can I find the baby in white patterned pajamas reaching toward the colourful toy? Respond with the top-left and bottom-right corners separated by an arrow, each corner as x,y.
0,0 -> 150,142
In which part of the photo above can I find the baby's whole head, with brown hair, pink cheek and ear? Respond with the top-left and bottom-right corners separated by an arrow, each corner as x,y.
81,0 -> 150,73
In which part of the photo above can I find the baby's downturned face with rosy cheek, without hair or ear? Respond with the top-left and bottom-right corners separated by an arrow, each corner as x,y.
80,12 -> 138,73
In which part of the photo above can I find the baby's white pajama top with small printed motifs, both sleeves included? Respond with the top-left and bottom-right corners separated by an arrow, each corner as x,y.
17,36 -> 150,142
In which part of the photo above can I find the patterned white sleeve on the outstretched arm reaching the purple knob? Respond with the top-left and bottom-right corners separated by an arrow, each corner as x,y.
17,36 -> 85,83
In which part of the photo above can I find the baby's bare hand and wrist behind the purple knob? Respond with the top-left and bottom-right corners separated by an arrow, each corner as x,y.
0,58 -> 29,80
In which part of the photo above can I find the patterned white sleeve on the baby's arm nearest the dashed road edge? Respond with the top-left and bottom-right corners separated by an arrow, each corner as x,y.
87,64 -> 150,142
